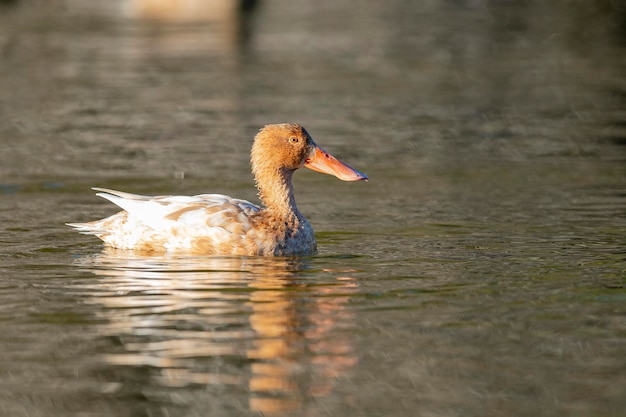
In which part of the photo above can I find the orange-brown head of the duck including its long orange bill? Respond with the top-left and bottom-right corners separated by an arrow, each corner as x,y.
251,124 -> 368,181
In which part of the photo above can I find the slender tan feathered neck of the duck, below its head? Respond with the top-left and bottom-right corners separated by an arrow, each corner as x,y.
257,169 -> 300,221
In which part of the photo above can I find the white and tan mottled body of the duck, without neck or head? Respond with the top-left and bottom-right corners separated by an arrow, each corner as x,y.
72,188 -> 317,256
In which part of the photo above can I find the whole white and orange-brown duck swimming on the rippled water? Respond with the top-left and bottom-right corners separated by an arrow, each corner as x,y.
67,123 -> 368,256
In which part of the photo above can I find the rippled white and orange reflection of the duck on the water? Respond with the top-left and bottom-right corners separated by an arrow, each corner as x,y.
81,248 -> 357,414
